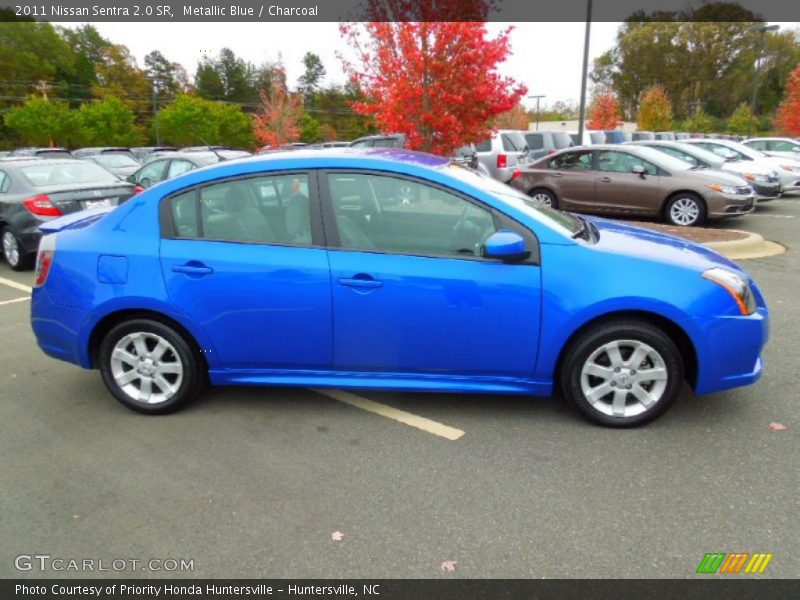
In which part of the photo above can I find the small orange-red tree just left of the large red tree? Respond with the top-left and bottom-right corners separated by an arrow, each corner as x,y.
253,69 -> 303,148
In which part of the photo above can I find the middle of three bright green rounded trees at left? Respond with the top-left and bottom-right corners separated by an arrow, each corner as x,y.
78,96 -> 142,146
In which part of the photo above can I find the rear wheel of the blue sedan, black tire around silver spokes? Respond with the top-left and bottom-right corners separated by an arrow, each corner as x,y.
97,318 -> 208,415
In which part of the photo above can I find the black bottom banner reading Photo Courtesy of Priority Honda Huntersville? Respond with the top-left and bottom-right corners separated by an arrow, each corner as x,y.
0,576 -> 800,600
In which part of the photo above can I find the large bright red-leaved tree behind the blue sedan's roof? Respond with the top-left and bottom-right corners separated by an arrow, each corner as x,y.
340,22 -> 527,154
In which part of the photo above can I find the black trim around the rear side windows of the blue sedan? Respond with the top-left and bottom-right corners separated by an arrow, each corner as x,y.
158,169 -> 327,248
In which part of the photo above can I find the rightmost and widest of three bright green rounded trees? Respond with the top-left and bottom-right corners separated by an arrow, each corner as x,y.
150,94 -> 253,147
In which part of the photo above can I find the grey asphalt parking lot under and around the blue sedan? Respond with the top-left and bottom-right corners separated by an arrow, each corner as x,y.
0,194 -> 800,578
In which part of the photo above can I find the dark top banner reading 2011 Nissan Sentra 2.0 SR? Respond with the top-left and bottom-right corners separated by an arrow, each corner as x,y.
0,0 -> 800,23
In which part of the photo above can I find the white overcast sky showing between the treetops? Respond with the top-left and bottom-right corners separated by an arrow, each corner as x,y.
59,23 -> 619,108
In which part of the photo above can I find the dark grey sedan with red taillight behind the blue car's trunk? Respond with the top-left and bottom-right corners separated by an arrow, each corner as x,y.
0,158 -> 136,271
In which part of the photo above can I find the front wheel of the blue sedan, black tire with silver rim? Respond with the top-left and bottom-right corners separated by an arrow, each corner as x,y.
559,319 -> 684,427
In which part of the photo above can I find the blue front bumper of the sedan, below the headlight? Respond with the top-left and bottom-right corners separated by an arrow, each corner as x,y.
692,307 -> 769,394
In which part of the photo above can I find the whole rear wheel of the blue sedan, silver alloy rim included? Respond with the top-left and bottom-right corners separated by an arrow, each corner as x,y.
98,319 -> 206,414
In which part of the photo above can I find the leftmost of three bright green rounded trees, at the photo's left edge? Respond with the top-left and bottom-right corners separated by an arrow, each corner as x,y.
5,97 -> 78,146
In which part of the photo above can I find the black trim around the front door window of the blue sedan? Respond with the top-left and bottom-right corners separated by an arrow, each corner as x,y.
318,168 -> 540,265
